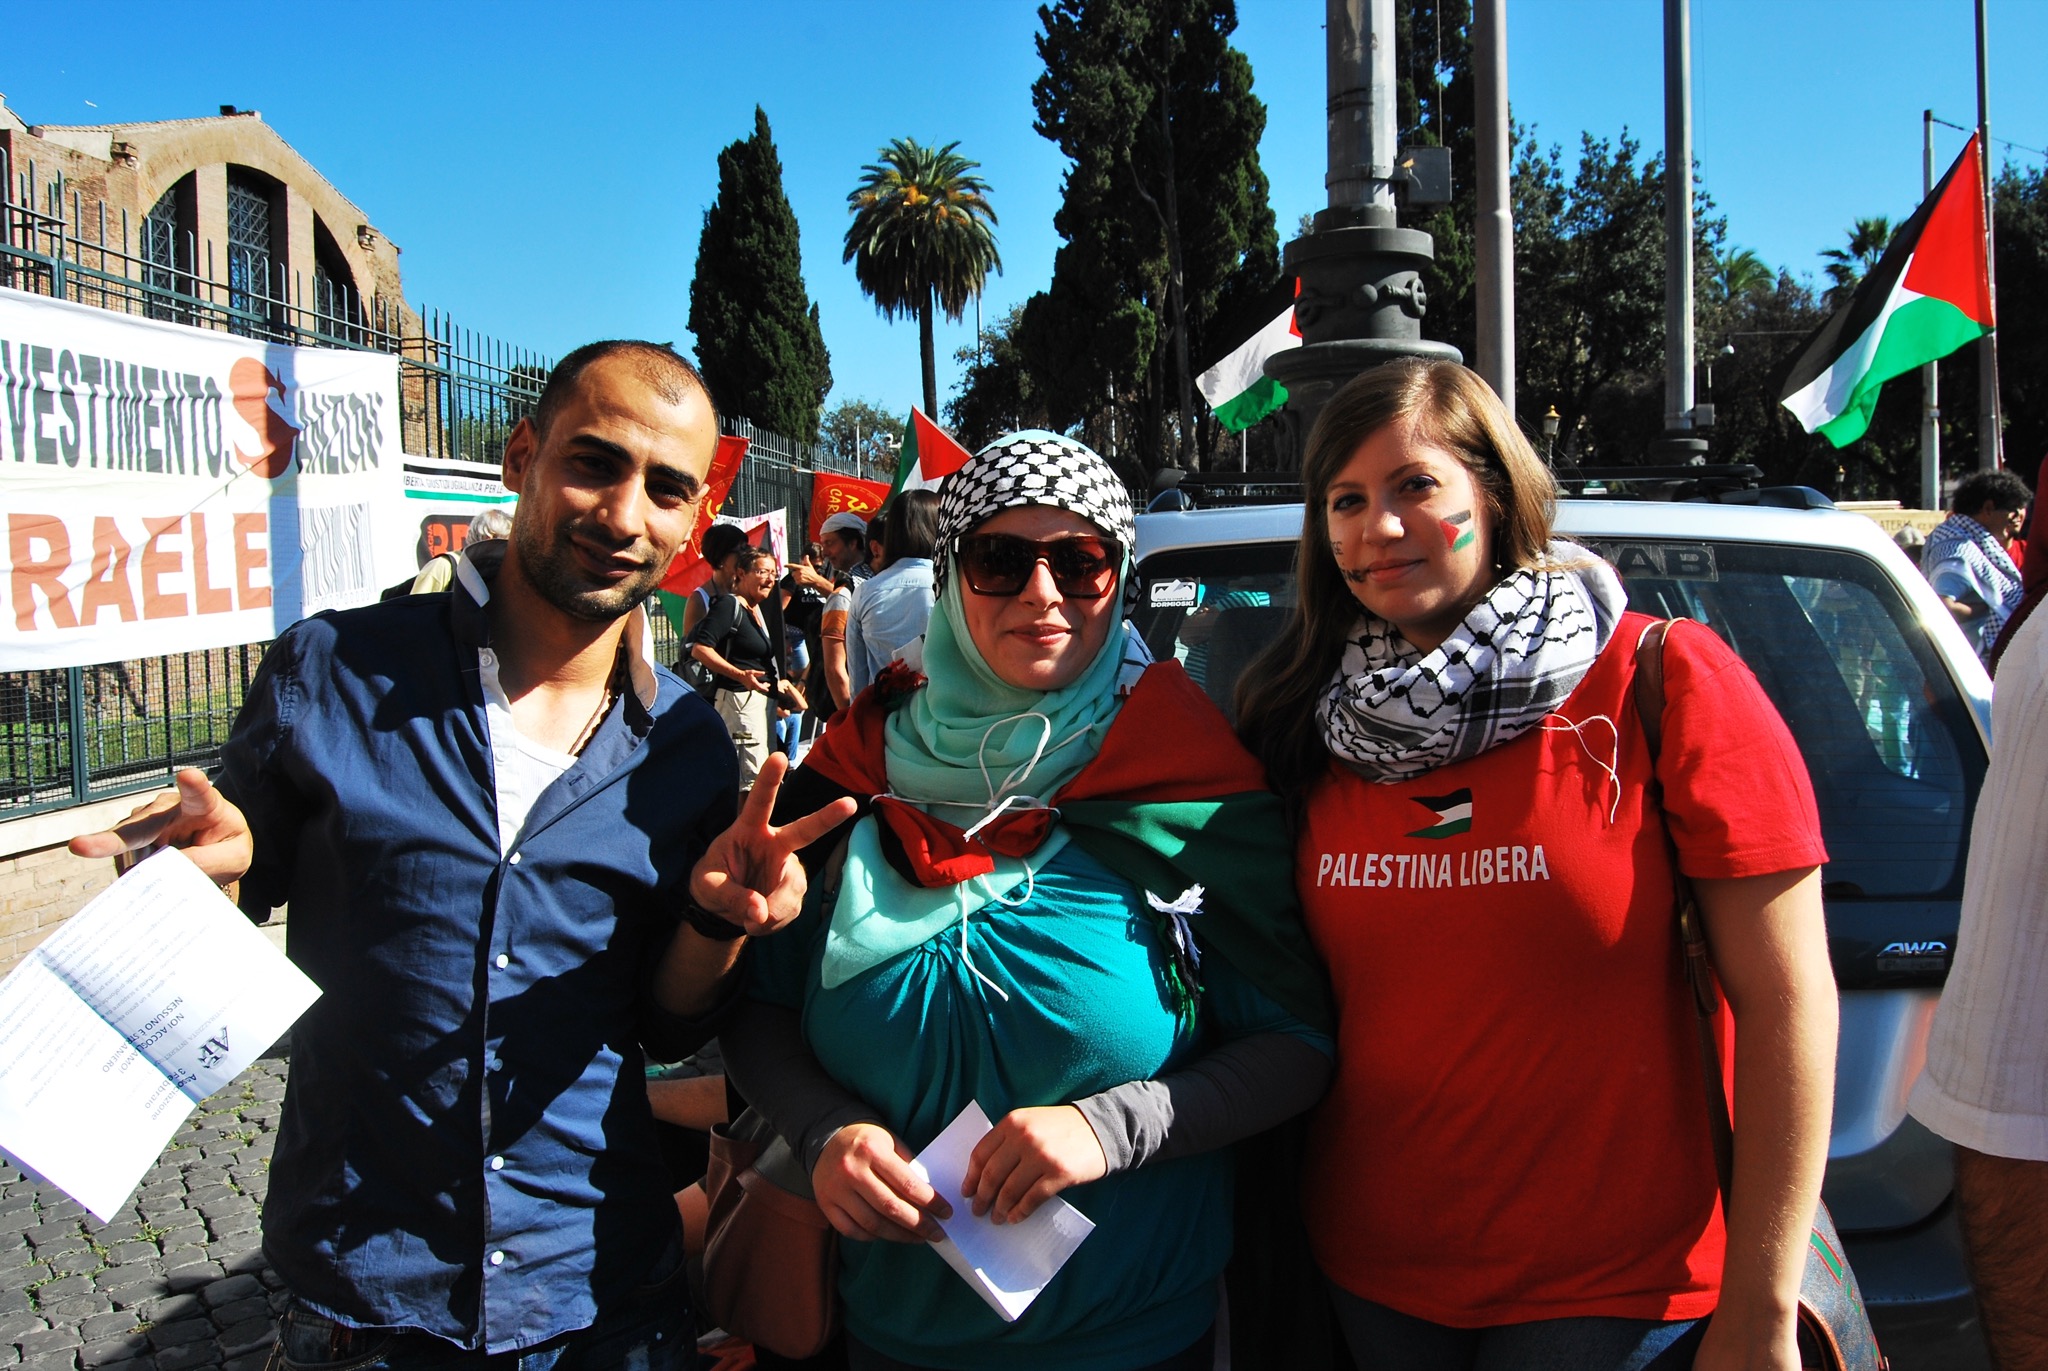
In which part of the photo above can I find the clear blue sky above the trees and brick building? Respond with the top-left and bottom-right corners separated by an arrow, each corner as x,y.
0,0 -> 2048,428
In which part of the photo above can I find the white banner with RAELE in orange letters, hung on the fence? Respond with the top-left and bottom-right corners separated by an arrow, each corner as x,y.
0,289 -> 418,670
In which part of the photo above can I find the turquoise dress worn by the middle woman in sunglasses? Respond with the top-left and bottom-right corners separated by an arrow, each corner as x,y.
752,844 -> 1333,1371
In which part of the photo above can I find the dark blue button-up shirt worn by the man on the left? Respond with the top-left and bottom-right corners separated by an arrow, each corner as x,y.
219,549 -> 737,1353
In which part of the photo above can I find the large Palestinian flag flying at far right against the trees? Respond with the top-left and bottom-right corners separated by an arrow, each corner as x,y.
1782,135 -> 1993,447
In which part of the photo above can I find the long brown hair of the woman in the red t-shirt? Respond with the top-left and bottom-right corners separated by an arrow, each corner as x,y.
1237,361 -> 1556,818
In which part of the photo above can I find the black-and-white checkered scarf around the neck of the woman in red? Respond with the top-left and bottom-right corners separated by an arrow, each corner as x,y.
1317,543 -> 1628,783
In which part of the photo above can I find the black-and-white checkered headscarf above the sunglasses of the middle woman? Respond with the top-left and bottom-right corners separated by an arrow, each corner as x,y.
932,428 -> 1137,592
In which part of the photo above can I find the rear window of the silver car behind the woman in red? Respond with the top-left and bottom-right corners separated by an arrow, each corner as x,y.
1133,539 -> 1985,900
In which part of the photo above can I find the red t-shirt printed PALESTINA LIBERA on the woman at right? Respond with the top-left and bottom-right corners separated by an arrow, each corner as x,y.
1296,615 -> 1827,1328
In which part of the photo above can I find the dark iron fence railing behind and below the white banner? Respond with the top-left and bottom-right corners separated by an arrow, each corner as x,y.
0,150 -> 854,820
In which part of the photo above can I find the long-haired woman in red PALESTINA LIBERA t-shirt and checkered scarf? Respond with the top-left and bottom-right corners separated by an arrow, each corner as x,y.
1239,363 -> 1835,1371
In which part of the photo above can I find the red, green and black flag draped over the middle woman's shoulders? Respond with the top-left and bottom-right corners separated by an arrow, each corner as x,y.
774,662 -> 1335,1033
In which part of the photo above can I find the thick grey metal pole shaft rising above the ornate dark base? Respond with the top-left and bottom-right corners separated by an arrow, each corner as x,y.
1323,0 -> 1395,223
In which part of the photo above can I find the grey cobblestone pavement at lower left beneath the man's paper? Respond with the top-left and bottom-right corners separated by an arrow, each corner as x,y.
0,1055 -> 287,1371
